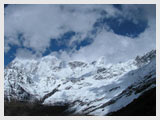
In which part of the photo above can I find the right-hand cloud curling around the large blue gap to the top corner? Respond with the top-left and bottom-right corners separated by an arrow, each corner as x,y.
58,5 -> 156,63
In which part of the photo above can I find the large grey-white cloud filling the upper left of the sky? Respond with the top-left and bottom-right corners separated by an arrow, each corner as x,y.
5,5 -> 117,52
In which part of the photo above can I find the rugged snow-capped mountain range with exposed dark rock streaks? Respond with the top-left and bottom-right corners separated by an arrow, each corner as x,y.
4,50 -> 156,115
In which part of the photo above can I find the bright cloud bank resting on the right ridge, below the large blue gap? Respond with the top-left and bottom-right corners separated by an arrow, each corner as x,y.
71,24 -> 155,63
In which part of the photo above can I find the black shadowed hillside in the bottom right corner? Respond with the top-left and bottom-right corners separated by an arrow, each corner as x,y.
108,88 -> 156,116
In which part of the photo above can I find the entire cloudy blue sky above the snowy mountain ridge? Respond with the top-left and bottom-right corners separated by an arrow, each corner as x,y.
4,4 -> 156,66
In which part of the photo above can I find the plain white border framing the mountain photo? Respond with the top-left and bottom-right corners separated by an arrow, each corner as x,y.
0,0 -> 160,120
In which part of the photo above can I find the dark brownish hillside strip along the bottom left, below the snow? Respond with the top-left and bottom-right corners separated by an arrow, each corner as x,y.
4,101 -> 68,116
